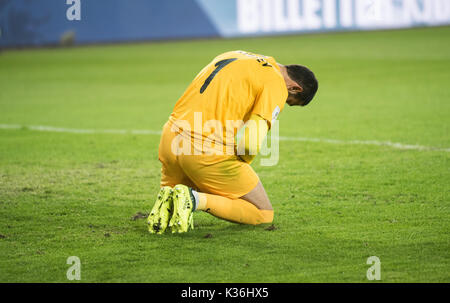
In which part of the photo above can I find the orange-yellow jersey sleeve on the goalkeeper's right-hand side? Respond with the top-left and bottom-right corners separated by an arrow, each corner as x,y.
251,79 -> 288,129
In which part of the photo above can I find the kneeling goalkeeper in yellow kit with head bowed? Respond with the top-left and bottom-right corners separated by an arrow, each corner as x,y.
147,51 -> 318,234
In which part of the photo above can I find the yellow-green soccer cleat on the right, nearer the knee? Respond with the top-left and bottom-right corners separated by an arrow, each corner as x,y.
169,184 -> 194,233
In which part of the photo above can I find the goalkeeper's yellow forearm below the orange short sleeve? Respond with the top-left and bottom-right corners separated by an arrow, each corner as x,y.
237,114 -> 269,164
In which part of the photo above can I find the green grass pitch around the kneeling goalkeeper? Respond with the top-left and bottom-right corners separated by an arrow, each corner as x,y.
0,27 -> 450,283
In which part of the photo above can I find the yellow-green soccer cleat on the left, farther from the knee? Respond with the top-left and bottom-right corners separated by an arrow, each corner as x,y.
147,186 -> 173,234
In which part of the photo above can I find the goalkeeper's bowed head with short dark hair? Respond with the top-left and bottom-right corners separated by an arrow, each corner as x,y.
285,64 -> 319,106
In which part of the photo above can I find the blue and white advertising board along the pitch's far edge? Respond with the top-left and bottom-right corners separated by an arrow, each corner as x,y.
0,0 -> 450,47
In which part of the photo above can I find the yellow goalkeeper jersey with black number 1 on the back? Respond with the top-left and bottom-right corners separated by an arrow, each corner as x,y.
169,51 -> 288,154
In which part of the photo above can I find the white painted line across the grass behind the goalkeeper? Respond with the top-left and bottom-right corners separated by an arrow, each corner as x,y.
0,124 -> 450,152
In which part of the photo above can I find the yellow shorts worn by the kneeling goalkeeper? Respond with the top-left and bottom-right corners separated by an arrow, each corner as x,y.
158,122 -> 259,199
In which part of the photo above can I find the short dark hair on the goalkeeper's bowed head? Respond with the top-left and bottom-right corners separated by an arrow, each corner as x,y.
286,64 -> 319,106
